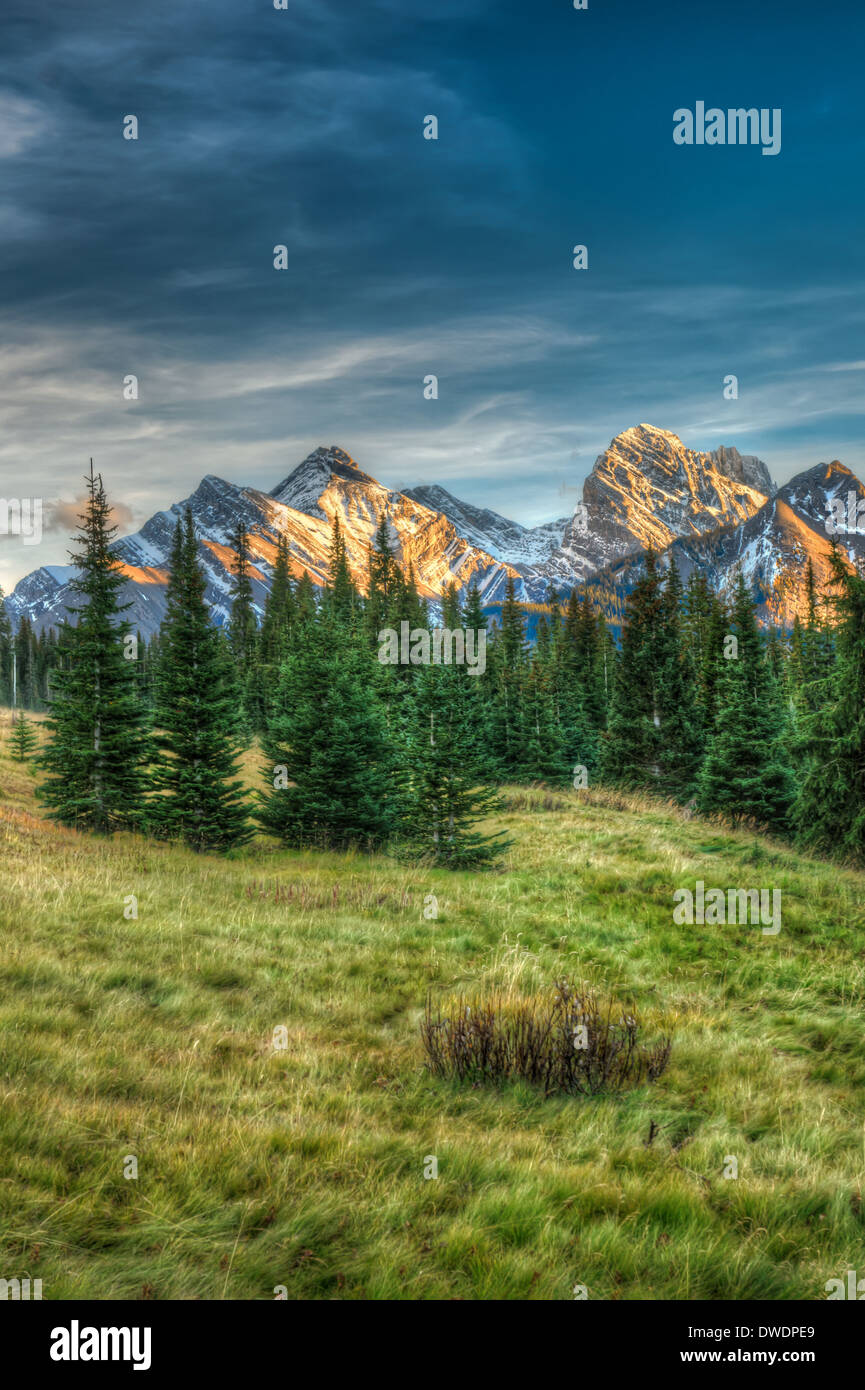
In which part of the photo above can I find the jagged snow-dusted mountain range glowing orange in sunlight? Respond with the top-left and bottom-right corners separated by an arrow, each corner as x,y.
6,424 -> 865,635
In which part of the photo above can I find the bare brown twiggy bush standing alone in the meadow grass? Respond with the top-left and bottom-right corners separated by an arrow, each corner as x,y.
421,980 -> 673,1095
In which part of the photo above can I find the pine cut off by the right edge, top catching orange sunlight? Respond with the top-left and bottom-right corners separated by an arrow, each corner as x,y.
793,545 -> 865,863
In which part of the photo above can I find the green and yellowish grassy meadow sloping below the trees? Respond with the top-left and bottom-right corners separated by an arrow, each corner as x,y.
0,716 -> 865,1300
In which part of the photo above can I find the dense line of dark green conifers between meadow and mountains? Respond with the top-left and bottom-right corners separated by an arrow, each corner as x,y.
6,473 -> 865,867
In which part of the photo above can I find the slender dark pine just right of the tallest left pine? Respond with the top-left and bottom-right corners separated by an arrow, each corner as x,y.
152,509 -> 252,851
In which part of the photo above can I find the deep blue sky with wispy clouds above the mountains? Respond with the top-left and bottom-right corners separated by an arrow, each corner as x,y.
0,0 -> 865,592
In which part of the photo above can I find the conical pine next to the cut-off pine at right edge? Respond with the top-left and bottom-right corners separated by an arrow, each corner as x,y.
697,570 -> 794,830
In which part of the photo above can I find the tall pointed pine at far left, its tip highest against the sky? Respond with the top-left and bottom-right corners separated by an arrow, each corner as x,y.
38,463 -> 150,834
